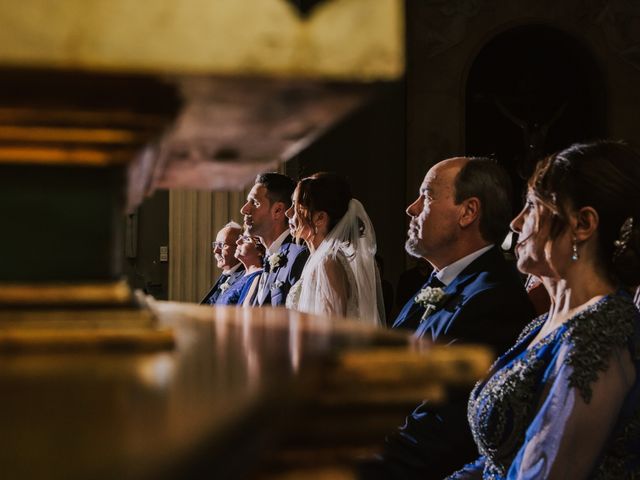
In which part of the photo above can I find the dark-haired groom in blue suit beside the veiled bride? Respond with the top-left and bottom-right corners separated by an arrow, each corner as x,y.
240,173 -> 309,306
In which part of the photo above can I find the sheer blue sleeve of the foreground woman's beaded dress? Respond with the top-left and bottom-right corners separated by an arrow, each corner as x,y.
507,345 -> 635,480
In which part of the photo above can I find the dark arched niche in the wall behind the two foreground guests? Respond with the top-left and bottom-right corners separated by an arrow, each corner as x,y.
465,25 -> 606,194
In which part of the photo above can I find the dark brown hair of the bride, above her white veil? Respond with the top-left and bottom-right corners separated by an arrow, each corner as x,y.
294,172 -> 353,239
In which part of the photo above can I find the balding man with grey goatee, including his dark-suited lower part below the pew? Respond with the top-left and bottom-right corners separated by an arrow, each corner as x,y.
361,157 -> 535,479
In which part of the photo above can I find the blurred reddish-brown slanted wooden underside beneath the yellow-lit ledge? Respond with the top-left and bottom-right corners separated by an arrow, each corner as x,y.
153,76 -> 372,191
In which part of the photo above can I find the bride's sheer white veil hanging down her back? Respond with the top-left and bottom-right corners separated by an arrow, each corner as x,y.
297,198 -> 384,325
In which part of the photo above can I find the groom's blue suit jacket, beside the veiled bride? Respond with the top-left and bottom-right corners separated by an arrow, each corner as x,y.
254,235 -> 309,307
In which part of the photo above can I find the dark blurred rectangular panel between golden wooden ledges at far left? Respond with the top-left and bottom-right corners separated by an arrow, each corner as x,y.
0,163 -> 124,284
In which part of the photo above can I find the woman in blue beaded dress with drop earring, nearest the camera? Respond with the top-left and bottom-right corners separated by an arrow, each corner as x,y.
450,142 -> 640,479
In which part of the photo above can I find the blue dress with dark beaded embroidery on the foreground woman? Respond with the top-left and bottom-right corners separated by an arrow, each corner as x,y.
449,292 -> 640,479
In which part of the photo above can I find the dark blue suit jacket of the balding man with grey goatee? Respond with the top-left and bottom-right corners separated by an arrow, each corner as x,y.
393,247 -> 535,353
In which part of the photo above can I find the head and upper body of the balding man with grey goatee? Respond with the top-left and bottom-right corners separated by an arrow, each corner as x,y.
393,157 -> 534,353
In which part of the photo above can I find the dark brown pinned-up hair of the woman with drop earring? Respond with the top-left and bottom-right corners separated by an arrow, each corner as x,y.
529,141 -> 640,287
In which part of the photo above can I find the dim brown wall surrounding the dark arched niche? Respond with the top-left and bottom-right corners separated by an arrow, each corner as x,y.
406,0 -> 640,201
